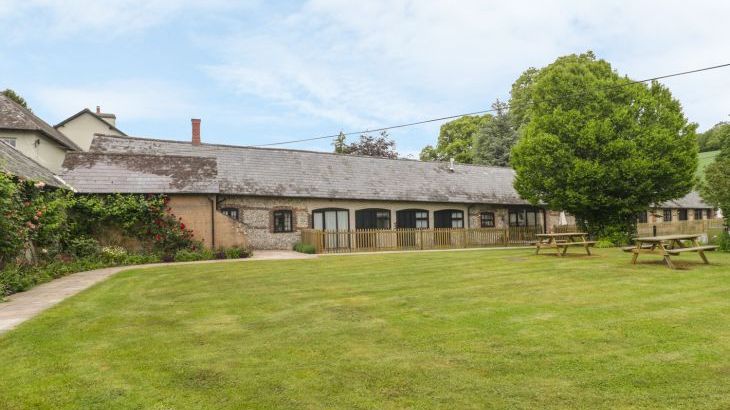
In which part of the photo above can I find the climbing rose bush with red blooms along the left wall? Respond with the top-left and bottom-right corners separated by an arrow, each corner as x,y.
0,173 -> 201,269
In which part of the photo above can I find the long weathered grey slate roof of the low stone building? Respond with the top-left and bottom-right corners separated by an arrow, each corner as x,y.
62,135 -> 527,204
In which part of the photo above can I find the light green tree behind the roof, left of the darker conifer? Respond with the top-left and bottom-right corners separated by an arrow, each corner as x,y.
420,114 -> 492,164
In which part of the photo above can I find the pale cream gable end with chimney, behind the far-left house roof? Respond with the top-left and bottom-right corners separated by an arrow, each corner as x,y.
54,105 -> 127,151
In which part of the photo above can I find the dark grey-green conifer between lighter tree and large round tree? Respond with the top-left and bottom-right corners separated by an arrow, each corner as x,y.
474,100 -> 517,167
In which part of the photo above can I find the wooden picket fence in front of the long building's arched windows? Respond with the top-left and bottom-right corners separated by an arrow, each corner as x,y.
301,226 -> 543,253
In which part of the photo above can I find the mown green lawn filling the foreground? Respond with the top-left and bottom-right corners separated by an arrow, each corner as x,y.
0,249 -> 730,409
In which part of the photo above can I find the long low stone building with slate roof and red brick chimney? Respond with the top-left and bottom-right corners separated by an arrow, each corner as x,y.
62,120 -> 559,249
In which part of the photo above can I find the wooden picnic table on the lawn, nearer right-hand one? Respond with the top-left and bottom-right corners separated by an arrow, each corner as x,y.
624,234 -> 717,269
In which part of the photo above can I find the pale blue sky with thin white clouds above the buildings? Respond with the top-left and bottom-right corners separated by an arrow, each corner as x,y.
0,0 -> 730,157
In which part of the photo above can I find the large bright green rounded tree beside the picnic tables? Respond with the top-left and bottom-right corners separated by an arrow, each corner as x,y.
510,52 -> 697,235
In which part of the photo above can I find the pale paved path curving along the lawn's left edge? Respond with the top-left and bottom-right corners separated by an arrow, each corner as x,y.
0,251 -> 317,335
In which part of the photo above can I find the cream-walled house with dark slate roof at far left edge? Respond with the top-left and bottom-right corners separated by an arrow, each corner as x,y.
0,94 -> 81,172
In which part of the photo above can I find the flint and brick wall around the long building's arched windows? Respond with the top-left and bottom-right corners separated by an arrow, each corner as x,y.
213,196 -> 544,249
